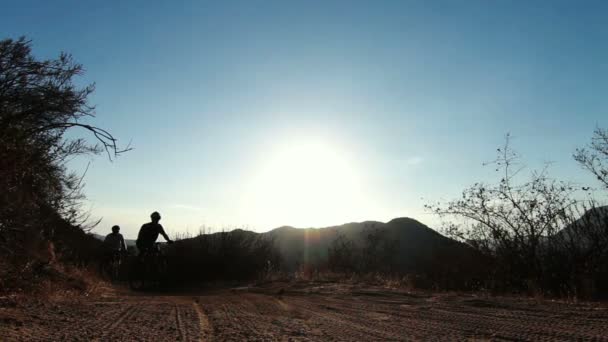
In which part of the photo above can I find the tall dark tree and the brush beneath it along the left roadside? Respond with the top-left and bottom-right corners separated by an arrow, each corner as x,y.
0,38 -> 126,292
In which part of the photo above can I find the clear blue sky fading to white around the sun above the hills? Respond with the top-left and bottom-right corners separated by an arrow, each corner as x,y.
0,1 -> 608,238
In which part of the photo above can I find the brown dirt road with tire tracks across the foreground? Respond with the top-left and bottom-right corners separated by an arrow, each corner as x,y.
0,285 -> 608,341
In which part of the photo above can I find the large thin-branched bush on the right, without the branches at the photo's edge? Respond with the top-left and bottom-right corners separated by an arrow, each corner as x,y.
427,136 -> 608,296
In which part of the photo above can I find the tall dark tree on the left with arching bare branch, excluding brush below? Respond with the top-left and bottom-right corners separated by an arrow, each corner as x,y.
0,38 -> 125,260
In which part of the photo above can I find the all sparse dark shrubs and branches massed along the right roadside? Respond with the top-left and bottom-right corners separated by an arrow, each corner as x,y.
427,132 -> 608,298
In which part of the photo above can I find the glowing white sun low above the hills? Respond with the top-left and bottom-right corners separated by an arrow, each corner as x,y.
241,140 -> 365,227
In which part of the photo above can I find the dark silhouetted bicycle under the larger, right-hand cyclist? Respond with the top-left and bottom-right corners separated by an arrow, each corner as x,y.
129,242 -> 169,291
